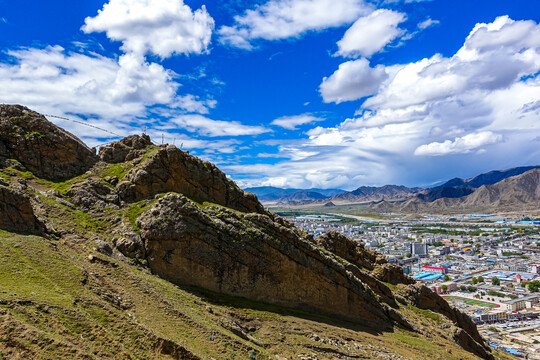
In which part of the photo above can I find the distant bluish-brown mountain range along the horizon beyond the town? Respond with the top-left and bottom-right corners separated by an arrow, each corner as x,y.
246,166 -> 540,212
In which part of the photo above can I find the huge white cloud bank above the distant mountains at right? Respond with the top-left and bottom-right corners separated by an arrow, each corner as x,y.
235,16 -> 540,188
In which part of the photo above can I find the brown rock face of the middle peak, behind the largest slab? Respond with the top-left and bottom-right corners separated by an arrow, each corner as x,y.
118,146 -> 265,213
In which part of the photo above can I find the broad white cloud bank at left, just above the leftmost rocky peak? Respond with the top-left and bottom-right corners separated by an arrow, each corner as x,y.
0,46 -> 221,145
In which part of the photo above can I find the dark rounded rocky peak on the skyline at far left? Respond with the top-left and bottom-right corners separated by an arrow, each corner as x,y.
0,105 -> 98,180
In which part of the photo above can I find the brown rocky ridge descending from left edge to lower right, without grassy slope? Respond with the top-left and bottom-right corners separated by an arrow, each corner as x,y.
0,106 -> 492,358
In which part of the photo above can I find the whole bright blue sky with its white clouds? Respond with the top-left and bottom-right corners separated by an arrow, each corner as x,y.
0,0 -> 540,189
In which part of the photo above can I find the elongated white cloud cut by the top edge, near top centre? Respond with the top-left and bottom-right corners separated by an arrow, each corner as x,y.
218,0 -> 373,49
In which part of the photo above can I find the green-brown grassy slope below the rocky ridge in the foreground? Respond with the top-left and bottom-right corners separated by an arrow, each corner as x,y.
0,232 -> 520,359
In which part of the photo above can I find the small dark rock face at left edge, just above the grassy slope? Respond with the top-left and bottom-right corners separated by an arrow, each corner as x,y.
0,185 -> 40,233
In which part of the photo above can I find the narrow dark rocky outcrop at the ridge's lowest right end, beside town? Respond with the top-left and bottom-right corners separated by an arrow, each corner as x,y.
399,284 -> 493,359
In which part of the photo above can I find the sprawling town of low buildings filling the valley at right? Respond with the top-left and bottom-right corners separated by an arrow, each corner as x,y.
281,212 -> 540,359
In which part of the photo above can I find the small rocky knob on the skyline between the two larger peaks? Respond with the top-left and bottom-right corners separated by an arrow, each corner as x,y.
99,134 -> 152,164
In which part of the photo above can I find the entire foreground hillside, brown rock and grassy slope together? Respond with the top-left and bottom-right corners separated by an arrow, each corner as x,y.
0,105 -> 493,359
